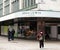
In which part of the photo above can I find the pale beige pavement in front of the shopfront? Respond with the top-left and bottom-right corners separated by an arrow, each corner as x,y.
0,37 -> 60,50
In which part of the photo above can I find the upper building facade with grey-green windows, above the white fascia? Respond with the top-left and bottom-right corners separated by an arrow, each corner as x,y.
0,0 -> 60,16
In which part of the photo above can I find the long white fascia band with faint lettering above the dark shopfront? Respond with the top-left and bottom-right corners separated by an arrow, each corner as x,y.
0,11 -> 60,21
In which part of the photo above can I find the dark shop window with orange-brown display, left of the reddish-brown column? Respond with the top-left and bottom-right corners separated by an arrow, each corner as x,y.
18,21 -> 37,38
